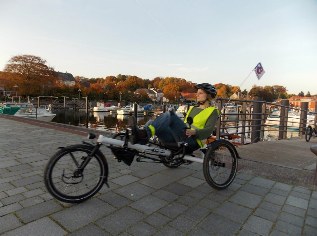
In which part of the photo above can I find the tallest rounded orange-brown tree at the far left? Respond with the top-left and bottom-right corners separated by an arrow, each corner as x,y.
4,55 -> 57,96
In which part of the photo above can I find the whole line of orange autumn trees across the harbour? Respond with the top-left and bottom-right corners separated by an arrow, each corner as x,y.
0,55 -> 310,102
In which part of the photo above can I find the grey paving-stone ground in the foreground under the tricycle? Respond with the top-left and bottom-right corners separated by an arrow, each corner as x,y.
0,116 -> 317,235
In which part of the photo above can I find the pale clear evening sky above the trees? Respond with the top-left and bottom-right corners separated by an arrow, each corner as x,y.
0,0 -> 317,94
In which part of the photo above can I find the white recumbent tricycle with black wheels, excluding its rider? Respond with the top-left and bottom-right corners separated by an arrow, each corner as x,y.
44,131 -> 238,203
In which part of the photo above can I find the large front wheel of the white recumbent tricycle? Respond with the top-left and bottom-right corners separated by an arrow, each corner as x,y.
44,144 -> 108,203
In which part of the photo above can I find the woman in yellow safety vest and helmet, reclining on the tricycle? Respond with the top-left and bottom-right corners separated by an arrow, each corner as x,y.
129,83 -> 220,153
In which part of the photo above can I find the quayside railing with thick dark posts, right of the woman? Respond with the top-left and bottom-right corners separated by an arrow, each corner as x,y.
216,99 -> 317,144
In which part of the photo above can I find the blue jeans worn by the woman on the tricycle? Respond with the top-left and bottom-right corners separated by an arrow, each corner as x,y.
145,111 -> 199,153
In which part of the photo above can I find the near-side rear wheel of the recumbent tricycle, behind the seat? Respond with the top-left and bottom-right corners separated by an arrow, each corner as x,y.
203,139 -> 238,190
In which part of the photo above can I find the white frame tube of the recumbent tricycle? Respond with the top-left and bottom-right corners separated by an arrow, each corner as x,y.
97,135 -> 204,163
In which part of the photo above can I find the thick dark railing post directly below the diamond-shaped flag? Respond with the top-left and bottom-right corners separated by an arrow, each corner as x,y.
251,98 -> 263,143
